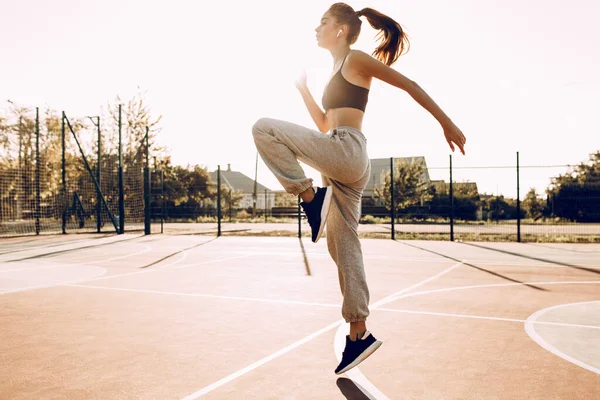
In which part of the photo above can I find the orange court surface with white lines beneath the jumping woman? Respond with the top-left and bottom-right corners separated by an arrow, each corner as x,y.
0,234 -> 600,399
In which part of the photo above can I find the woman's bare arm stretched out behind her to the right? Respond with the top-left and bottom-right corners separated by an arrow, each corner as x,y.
352,51 -> 467,154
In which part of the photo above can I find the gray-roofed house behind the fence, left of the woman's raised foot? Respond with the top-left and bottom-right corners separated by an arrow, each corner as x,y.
210,164 -> 275,210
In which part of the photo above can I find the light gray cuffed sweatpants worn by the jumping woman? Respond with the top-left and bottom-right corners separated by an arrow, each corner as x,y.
252,118 -> 371,322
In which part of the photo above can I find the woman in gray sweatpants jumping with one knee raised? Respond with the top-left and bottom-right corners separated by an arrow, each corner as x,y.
252,3 -> 466,374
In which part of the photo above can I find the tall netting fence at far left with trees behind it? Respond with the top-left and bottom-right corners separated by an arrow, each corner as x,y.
0,107 -> 144,236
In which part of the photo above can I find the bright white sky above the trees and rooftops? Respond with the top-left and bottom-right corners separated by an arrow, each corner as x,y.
0,0 -> 600,197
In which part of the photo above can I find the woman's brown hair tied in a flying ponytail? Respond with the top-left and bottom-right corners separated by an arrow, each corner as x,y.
327,3 -> 410,66
